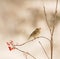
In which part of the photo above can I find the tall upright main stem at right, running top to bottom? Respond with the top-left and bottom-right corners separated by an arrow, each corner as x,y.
51,0 -> 58,59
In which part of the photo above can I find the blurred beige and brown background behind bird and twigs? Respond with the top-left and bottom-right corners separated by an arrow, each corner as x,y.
0,0 -> 60,59
